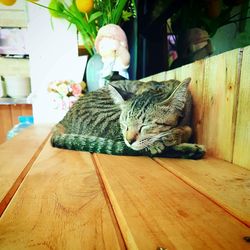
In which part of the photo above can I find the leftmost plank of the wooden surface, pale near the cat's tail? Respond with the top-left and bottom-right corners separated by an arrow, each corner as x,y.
0,126 -> 51,216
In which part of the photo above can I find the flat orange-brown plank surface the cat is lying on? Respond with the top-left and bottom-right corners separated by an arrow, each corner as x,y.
0,126 -> 250,250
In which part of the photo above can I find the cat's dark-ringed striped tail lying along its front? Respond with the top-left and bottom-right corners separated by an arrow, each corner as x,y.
51,128 -> 142,155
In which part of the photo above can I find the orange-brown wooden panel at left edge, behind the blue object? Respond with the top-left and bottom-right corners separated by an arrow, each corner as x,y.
0,104 -> 32,144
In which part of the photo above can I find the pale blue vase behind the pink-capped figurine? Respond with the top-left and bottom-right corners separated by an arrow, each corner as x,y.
86,53 -> 103,92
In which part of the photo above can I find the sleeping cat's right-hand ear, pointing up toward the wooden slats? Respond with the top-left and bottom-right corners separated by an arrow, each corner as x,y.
163,77 -> 191,113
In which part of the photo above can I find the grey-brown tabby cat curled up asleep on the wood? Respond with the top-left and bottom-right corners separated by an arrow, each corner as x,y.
51,78 -> 205,159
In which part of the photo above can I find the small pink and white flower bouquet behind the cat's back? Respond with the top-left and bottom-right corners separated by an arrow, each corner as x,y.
48,80 -> 86,111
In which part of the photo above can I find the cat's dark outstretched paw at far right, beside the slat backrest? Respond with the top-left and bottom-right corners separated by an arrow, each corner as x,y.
172,143 -> 206,159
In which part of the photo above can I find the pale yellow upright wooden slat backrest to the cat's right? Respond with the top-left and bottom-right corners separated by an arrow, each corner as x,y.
143,46 -> 250,169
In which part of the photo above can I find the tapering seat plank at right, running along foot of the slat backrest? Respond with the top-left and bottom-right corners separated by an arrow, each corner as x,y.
155,158 -> 250,227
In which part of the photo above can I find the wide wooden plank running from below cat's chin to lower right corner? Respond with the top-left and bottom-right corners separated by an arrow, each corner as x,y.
95,154 -> 250,250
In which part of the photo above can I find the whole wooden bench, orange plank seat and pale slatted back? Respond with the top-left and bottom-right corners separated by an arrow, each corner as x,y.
0,47 -> 250,250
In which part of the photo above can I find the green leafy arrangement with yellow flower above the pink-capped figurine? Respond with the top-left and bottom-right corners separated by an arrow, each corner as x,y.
28,0 -> 136,55
